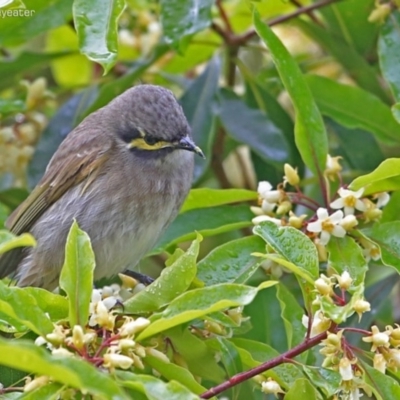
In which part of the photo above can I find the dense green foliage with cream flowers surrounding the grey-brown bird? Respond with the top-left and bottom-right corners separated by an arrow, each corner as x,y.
0,0 -> 400,400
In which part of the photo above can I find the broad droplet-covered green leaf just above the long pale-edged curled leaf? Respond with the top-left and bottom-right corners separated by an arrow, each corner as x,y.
197,236 -> 265,286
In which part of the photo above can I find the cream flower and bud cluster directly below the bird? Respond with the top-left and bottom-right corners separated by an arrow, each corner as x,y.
24,284 -> 169,391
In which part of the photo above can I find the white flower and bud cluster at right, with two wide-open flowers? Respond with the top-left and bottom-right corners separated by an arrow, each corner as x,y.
251,155 -> 390,261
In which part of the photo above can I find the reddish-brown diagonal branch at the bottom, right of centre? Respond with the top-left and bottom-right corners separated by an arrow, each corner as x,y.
200,331 -> 328,399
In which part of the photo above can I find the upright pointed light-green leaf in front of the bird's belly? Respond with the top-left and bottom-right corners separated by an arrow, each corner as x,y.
60,221 -> 95,326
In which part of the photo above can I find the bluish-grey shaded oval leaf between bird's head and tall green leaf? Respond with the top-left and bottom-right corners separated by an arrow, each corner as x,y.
220,89 -> 289,166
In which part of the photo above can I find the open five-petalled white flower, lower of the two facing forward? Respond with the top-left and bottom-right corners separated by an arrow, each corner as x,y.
307,208 -> 346,245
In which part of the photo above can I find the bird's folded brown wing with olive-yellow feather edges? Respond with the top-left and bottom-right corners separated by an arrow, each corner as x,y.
0,138 -> 108,278
